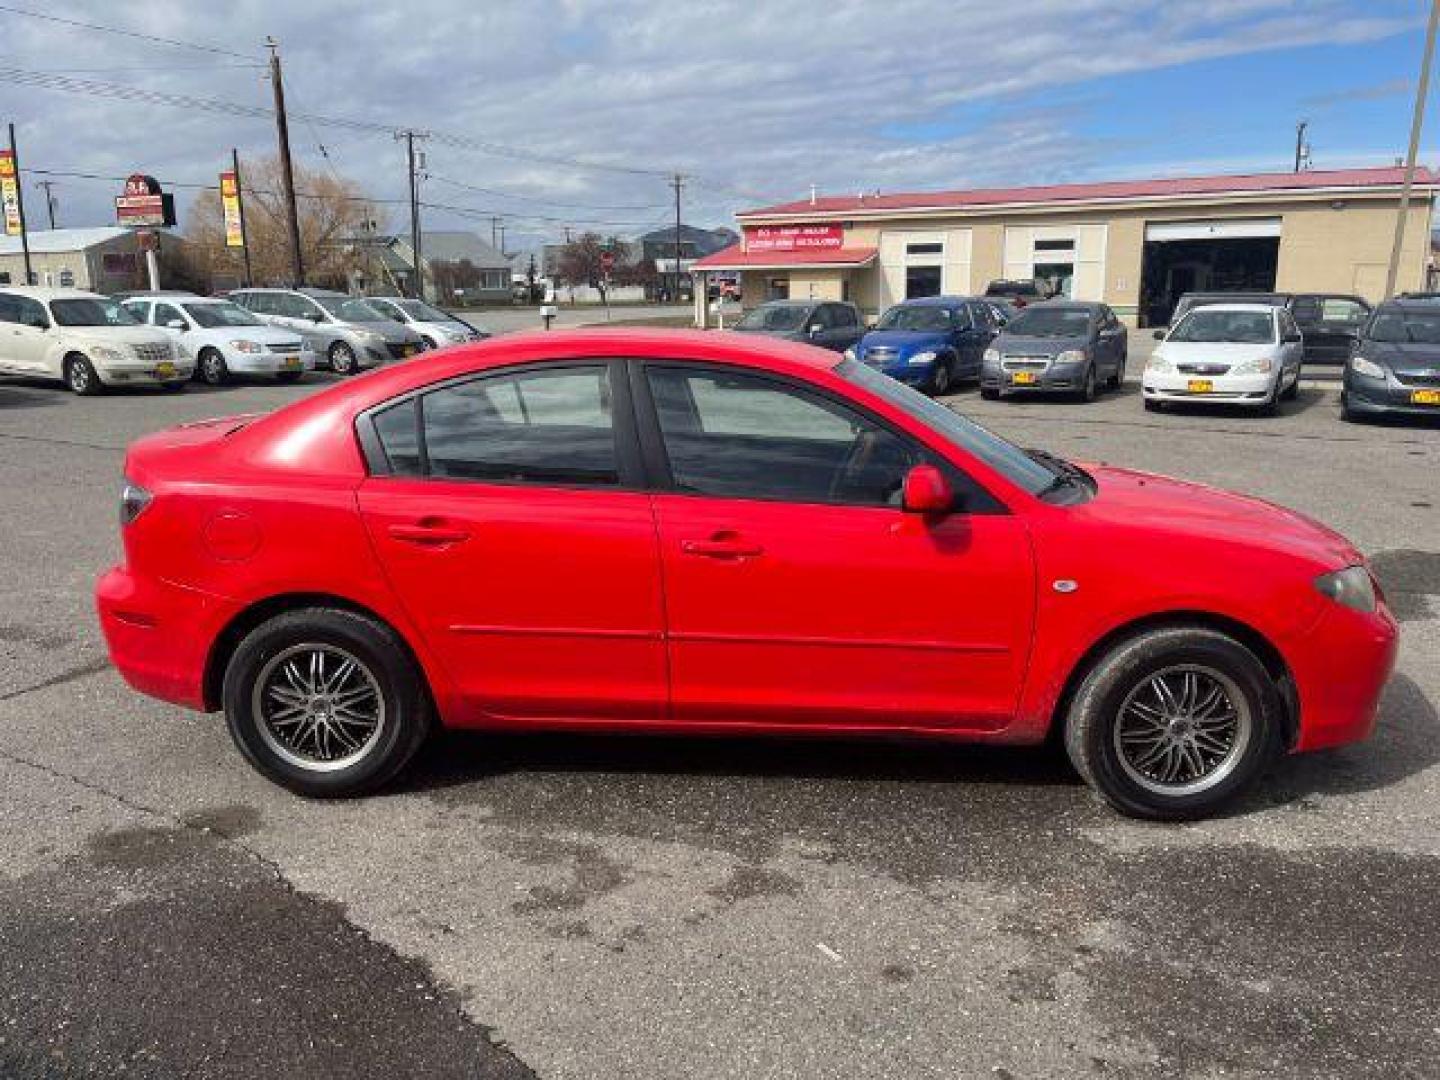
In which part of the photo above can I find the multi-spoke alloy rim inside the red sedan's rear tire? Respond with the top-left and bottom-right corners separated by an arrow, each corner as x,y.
251,644 -> 386,772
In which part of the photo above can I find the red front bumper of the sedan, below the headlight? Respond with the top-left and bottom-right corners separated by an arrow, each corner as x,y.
1286,603 -> 1400,750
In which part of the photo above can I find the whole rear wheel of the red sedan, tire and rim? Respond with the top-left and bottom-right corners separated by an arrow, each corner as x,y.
222,608 -> 431,798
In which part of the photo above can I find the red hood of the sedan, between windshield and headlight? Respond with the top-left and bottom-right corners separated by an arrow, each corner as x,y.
1084,465 -> 1362,569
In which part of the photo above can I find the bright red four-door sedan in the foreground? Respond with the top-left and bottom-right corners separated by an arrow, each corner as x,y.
96,330 -> 1398,818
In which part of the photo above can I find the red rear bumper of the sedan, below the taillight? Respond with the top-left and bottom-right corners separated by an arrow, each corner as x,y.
95,566 -> 239,710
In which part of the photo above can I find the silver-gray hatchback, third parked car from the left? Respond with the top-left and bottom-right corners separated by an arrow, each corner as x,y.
229,289 -> 425,374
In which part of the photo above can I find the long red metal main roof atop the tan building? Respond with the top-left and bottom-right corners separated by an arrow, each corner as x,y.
736,167 -> 1437,217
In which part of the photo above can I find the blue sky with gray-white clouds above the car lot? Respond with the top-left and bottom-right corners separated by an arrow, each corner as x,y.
0,0 -> 1440,249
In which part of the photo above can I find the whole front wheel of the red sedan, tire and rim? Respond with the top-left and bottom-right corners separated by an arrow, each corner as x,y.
1066,626 -> 1283,821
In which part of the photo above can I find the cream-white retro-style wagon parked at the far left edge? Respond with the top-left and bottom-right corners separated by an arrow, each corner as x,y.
0,285 -> 194,395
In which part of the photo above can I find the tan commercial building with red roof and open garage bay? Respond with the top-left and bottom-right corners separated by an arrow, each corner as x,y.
696,168 -> 1437,325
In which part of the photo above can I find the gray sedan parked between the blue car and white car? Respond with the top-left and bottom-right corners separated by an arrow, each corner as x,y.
981,300 -> 1129,402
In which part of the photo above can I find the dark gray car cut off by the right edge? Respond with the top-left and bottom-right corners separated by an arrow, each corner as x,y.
1341,300 -> 1440,420
